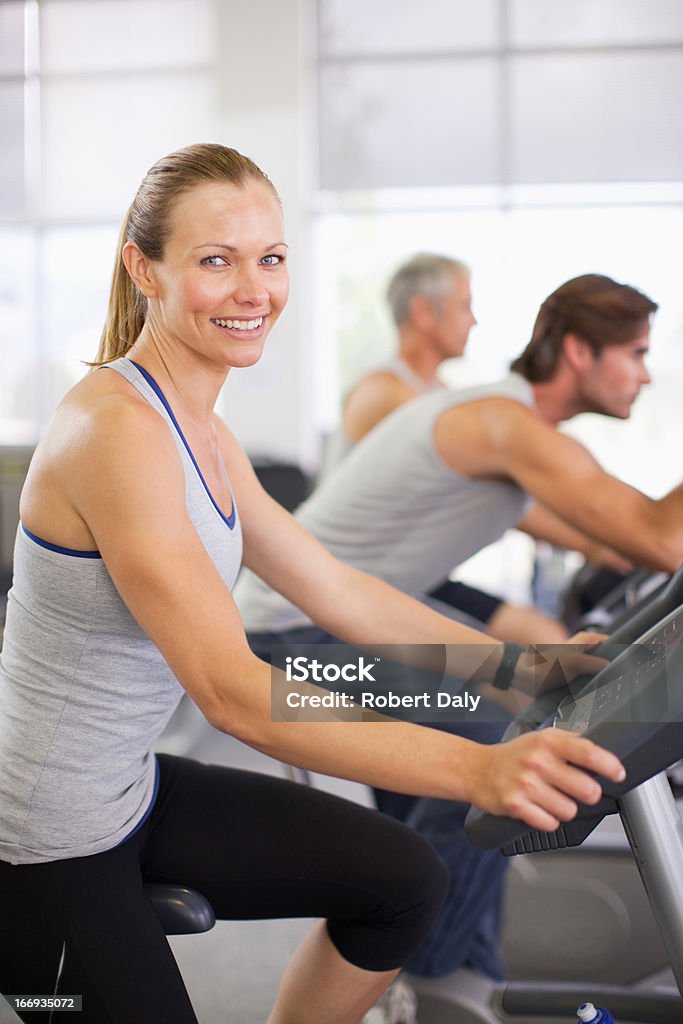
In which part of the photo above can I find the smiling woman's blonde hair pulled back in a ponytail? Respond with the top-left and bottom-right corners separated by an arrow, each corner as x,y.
90,143 -> 280,367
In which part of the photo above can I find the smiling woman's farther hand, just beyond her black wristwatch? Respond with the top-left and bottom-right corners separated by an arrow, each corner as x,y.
513,632 -> 607,697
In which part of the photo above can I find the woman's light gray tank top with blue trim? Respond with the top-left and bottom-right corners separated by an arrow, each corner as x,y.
0,358 -> 242,864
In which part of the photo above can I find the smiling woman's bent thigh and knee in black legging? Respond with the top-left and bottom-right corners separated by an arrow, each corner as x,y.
142,756 -> 445,970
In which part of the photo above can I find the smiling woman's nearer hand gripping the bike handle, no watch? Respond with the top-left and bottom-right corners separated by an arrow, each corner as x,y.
472,729 -> 626,831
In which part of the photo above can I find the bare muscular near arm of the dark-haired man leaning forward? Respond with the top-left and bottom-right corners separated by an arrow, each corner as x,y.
434,398 -> 683,572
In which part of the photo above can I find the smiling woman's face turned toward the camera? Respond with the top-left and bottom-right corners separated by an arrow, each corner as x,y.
147,179 -> 289,367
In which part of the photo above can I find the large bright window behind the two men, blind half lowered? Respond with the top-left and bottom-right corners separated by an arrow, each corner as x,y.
314,0 -> 683,599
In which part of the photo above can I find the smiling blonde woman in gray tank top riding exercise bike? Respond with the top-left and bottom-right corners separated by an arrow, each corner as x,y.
0,145 -> 623,1024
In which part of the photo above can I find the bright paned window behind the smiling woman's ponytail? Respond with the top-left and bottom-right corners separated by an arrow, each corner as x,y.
0,0 -> 218,443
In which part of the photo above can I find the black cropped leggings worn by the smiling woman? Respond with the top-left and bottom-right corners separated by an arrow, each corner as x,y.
0,756 -> 447,1024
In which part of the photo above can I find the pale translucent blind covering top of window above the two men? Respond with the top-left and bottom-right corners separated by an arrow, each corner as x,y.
318,0 -> 683,189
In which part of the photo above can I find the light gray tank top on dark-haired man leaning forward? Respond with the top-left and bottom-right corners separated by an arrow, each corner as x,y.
234,374 -> 533,633
